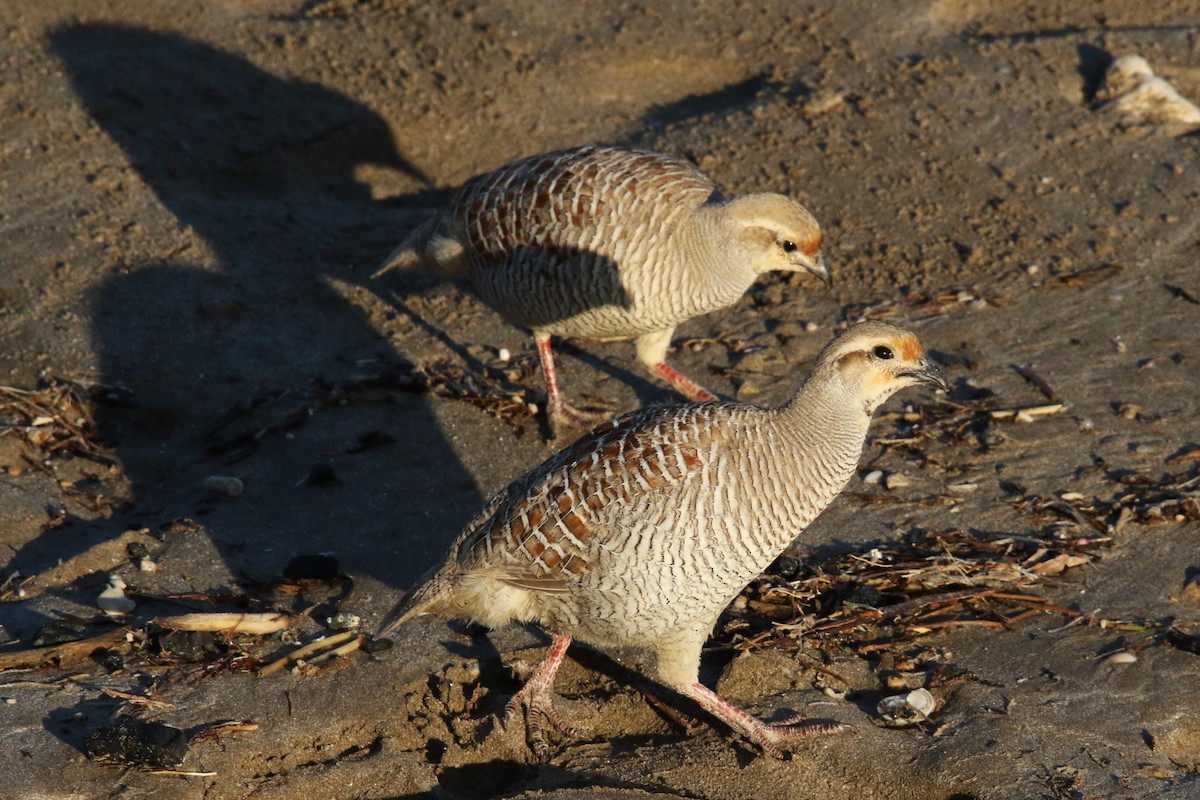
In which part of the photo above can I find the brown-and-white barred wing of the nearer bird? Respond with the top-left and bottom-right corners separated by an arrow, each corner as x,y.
457,403 -> 724,593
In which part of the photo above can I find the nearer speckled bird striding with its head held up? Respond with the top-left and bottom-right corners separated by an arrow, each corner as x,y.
378,321 -> 947,759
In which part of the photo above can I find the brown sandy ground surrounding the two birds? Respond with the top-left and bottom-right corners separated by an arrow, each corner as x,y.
0,0 -> 1200,800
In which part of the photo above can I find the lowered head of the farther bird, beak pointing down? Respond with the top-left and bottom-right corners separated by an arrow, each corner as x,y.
725,193 -> 833,287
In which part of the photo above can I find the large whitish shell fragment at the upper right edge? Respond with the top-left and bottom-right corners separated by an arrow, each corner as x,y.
1103,55 -> 1200,136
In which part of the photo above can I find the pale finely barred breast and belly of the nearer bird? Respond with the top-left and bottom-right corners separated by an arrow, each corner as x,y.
482,407 -> 862,645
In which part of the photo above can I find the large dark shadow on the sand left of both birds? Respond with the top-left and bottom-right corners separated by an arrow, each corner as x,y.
8,24 -> 481,618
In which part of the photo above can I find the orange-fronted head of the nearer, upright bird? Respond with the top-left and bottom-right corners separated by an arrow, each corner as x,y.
812,321 -> 948,415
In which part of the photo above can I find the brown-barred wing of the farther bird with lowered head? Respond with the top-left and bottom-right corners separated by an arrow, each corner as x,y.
450,146 -> 719,259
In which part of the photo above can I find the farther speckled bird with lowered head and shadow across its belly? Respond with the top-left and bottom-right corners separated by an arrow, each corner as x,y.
374,145 -> 830,435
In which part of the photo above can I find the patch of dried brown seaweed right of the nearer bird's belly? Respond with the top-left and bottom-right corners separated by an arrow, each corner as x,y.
718,529 -> 1108,652
